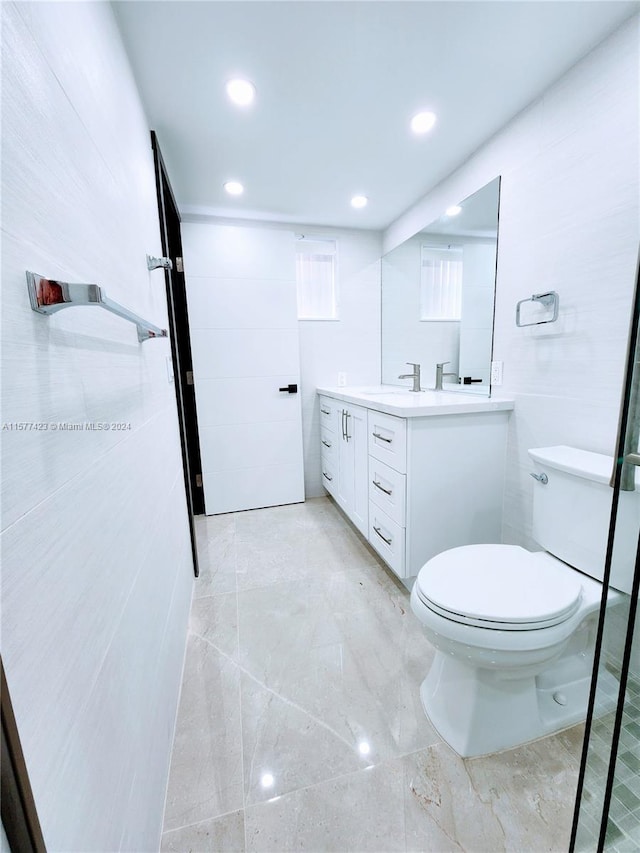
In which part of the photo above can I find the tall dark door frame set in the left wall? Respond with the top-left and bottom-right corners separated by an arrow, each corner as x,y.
151,130 -> 204,577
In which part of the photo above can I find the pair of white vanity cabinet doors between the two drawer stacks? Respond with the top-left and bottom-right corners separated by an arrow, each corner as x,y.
336,404 -> 369,536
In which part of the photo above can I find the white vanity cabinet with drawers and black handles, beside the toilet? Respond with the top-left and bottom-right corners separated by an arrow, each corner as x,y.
321,389 -> 513,580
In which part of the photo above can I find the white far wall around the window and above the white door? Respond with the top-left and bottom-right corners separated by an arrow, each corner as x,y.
178,215 -> 381,498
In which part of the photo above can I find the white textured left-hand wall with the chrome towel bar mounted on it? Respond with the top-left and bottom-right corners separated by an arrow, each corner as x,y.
0,3 -> 193,851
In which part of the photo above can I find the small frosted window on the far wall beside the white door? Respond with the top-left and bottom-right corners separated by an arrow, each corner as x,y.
296,237 -> 338,320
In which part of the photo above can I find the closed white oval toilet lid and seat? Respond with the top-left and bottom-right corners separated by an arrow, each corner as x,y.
416,545 -> 582,631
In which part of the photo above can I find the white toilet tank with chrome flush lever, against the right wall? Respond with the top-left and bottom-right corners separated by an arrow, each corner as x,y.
529,445 -> 640,593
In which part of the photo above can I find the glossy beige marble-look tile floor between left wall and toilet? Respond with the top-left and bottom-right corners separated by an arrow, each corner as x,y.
162,498 -> 583,853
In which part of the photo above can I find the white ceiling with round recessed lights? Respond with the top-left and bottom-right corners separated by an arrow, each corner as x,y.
112,0 -> 640,229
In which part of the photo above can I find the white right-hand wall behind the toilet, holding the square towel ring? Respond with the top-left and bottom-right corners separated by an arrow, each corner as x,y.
384,16 -> 640,545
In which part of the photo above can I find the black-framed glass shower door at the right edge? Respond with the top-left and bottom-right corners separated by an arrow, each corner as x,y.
570,255 -> 640,853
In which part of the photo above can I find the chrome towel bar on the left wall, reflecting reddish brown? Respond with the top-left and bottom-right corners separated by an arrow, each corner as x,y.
27,272 -> 168,342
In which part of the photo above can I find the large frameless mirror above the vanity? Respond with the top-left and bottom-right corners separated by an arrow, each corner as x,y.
381,177 -> 500,395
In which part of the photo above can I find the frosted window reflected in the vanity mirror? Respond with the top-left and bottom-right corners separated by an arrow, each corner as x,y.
420,246 -> 462,320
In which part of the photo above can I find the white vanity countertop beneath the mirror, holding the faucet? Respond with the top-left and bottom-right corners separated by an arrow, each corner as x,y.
316,385 -> 514,418
